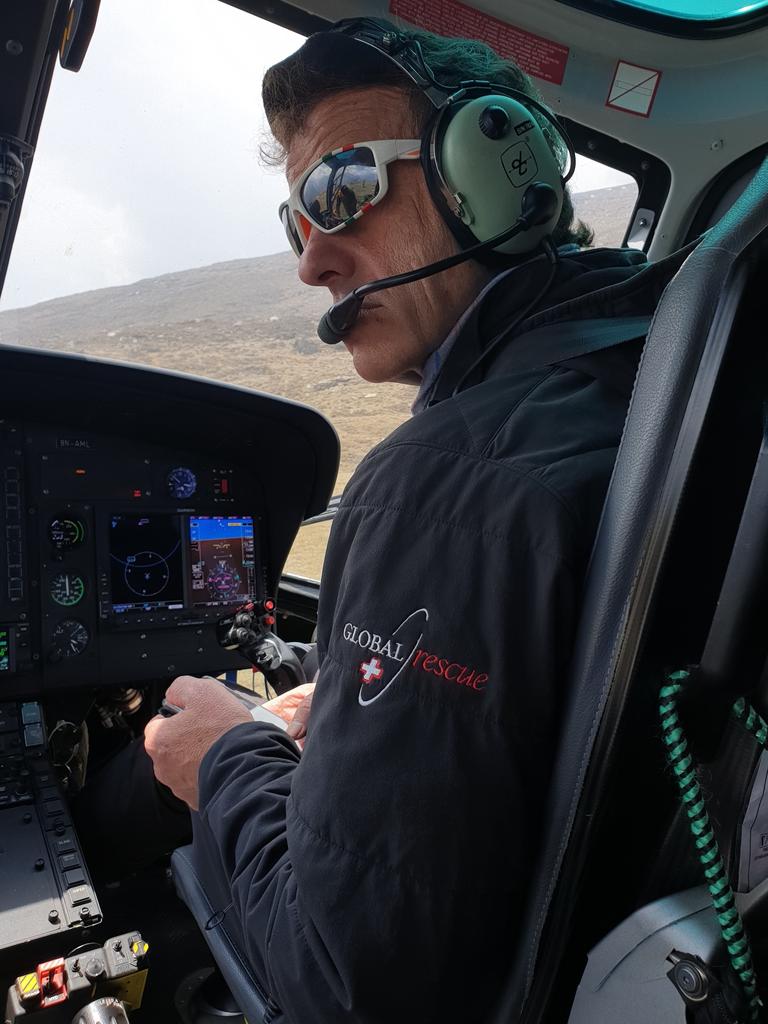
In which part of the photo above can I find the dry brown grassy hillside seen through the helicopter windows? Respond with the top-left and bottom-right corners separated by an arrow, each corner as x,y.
0,185 -> 632,578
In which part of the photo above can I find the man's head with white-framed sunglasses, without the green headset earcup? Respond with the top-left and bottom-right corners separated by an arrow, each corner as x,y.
263,19 -> 586,382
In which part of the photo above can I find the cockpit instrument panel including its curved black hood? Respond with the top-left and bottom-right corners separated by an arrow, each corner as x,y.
0,345 -> 339,700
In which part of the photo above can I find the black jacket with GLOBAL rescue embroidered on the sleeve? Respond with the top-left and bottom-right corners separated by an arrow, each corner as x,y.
200,243 -> 688,1024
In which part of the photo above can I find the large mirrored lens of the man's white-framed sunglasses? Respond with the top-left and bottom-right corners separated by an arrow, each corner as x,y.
301,146 -> 379,230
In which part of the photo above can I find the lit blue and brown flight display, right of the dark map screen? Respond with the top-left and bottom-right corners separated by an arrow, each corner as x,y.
189,516 -> 255,607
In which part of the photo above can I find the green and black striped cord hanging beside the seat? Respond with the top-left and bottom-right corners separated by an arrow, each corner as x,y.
658,671 -> 768,1022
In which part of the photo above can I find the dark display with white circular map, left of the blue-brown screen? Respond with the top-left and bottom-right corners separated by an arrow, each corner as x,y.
110,515 -> 184,613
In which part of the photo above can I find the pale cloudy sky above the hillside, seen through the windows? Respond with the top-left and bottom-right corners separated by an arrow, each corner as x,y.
0,0 -> 628,309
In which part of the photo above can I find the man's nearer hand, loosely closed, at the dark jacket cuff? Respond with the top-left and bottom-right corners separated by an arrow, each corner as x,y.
144,676 -> 252,811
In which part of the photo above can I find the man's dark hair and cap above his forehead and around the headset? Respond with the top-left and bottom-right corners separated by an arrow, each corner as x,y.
261,23 -> 594,246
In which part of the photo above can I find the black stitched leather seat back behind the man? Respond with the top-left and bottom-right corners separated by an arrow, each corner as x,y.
496,161 -> 768,1024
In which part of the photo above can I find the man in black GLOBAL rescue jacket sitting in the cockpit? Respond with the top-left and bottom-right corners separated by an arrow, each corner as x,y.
140,18 -> 684,1024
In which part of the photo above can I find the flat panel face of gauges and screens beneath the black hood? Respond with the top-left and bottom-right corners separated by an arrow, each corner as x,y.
0,422 -> 265,693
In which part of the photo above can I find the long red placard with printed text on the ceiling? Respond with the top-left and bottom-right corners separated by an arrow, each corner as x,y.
389,0 -> 568,85
